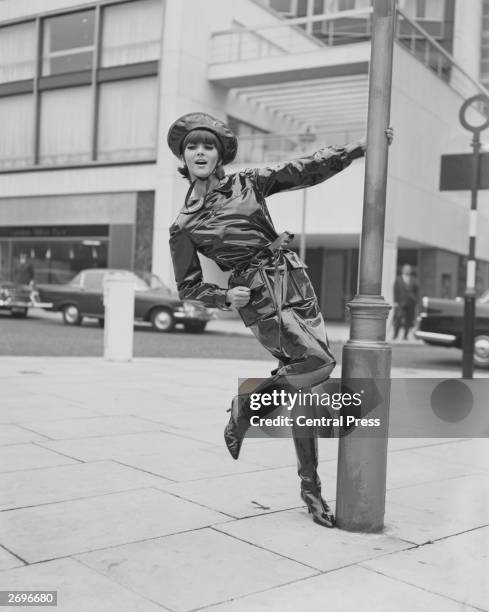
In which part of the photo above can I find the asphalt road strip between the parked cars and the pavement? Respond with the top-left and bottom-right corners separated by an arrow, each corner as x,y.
0,310 -> 468,375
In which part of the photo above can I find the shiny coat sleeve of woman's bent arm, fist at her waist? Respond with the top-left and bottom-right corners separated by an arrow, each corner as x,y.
170,225 -> 228,310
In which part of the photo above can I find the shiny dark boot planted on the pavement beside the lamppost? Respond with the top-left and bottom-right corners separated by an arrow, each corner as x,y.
294,435 -> 335,528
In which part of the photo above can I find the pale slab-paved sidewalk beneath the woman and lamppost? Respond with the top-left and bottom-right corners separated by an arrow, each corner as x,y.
0,350 -> 489,612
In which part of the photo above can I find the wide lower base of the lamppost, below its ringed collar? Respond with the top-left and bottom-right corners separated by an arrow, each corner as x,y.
336,295 -> 391,532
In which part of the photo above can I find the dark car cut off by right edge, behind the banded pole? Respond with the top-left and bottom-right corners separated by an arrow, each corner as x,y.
414,289 -> 489,368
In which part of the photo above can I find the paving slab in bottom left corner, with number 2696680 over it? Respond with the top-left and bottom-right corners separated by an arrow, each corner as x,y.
0,559 -> 164,612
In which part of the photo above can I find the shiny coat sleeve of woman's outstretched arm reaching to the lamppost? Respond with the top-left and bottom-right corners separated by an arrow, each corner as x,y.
254,145 -> 364,197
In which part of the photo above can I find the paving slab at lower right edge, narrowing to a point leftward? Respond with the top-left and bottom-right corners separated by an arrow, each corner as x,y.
363,527 -> 489,610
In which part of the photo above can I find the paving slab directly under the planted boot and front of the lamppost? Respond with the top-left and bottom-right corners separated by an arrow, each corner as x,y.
216,504 -> 413,572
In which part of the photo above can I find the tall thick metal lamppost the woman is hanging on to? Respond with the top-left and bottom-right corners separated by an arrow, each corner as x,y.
336,0 -> 396,532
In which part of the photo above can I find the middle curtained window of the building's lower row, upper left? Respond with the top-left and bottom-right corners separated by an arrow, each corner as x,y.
39,87 -> 92,165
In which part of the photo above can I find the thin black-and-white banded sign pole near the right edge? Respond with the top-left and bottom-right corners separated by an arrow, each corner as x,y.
462,130 -> 481,378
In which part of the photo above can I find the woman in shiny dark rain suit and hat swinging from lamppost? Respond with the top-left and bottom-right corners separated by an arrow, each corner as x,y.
168,113 -> 392,527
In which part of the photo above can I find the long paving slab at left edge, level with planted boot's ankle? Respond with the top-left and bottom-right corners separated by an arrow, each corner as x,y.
0,461 -> 170,510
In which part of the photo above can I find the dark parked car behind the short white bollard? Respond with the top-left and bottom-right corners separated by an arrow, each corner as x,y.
37,268 -> 215,333
